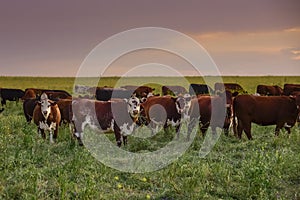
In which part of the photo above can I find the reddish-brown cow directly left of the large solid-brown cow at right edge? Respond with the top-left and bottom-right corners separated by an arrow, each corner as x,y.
188,91 -> 232,139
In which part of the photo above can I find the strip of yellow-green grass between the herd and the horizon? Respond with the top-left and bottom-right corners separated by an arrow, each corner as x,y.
0,76 -> 300,94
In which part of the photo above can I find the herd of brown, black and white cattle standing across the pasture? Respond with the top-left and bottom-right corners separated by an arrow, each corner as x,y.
0,83 -> 300,146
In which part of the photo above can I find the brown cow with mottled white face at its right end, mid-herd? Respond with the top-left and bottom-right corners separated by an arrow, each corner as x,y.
139,95 -> 191,138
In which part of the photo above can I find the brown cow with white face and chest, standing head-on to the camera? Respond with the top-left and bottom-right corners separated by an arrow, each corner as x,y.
33,93 -> 61,143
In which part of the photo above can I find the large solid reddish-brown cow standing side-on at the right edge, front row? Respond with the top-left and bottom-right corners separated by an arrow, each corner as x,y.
233,95 -> 300,140
